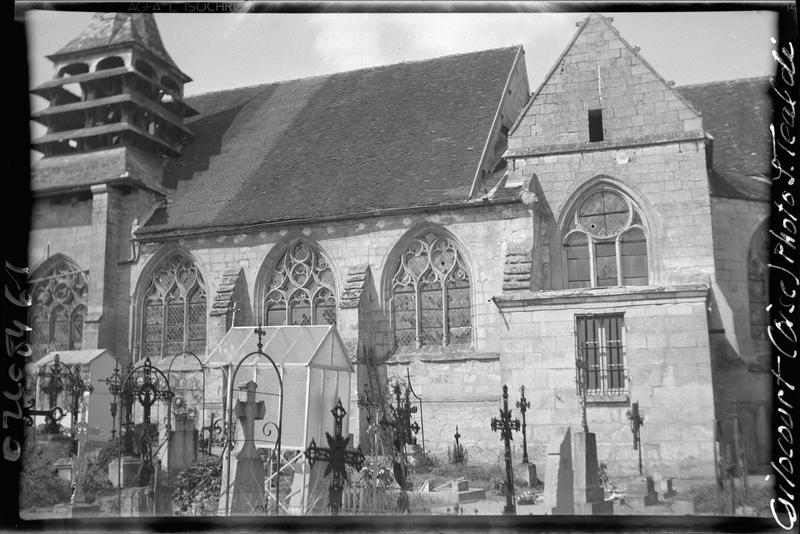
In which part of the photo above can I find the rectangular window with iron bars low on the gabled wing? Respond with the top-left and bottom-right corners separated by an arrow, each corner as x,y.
575,314 -> 628,396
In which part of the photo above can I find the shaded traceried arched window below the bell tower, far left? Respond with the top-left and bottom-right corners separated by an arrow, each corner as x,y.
28,260 -> 89,359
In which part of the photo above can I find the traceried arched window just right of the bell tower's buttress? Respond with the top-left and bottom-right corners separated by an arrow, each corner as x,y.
142,254 -> 207,358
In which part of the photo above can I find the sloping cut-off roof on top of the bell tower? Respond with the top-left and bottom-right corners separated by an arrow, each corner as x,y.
47,13 -> 189,80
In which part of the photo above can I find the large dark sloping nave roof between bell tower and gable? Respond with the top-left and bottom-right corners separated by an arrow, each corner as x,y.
139,47 -> 519,235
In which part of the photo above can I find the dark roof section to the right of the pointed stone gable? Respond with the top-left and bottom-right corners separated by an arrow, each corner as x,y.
676,77 -> 772,200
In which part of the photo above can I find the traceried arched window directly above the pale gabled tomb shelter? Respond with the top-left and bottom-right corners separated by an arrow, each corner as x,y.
264,240 -> 336,326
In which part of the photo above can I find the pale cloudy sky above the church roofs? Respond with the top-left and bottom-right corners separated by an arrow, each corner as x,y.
26,8 -> 776,101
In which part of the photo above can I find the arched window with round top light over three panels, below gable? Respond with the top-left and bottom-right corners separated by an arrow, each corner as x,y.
564,188 -> 648,288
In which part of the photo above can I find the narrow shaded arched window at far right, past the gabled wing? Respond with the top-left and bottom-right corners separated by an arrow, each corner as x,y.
747,225 -> 769,345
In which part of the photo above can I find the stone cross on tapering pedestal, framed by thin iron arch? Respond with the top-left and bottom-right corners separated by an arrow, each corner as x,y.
218,380 -> 266,515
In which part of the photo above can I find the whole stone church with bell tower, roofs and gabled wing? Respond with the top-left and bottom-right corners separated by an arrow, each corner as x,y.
29,13 -> 771,490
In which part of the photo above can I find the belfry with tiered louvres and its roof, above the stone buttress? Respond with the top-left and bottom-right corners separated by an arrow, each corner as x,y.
31,13 -> 197,194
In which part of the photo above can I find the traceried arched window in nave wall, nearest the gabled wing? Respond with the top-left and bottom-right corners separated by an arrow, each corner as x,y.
391,232 -> 472,348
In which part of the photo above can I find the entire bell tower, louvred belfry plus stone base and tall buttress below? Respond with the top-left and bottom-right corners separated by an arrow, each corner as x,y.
29,13 -> 197,363
